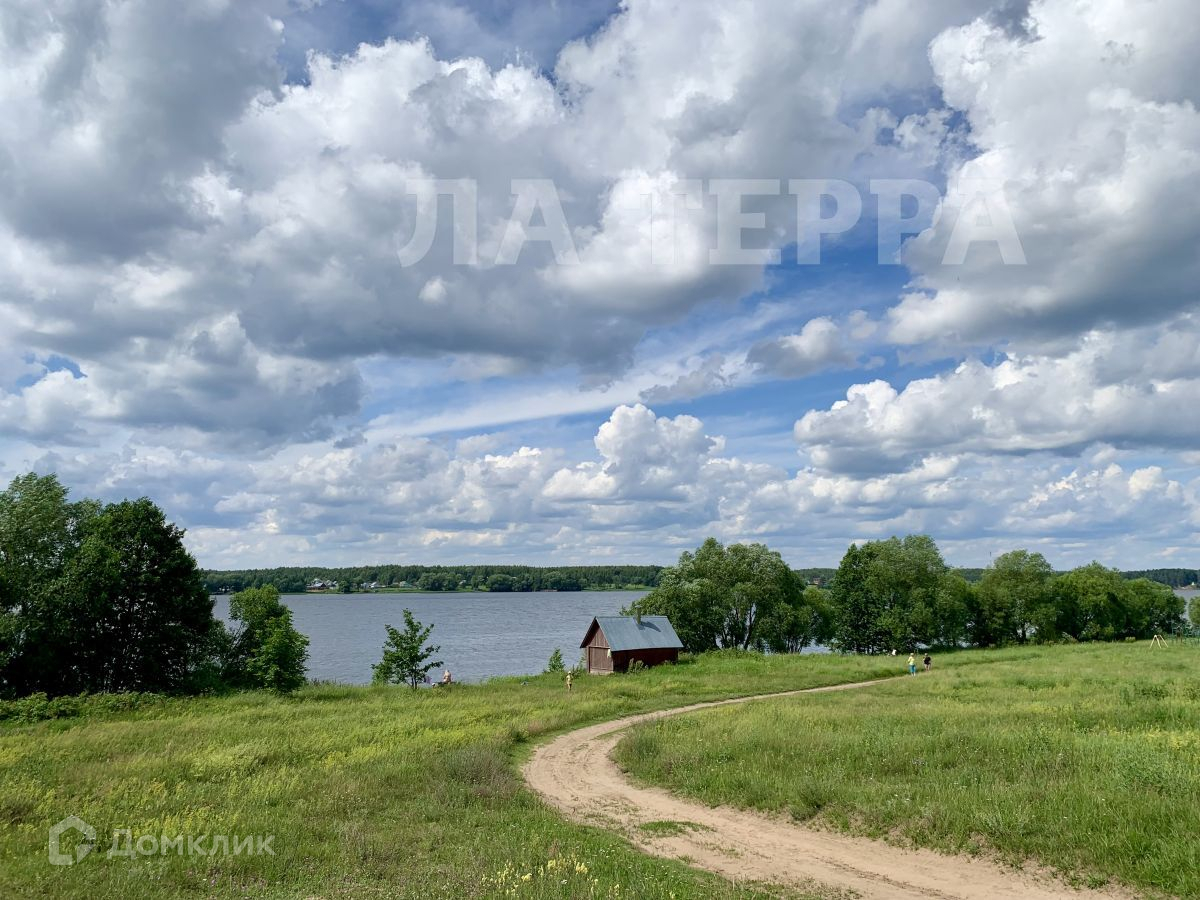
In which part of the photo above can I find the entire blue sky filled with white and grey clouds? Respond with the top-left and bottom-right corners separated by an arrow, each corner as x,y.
0,0 -> 1200,568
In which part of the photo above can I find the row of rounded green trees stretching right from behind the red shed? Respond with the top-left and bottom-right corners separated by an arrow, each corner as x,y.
626,534 -> 1200,653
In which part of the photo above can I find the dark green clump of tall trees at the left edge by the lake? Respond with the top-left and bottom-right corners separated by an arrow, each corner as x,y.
0,474 -> 306,697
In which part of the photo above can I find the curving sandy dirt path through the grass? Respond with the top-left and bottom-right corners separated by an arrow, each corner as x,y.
523,680 -> 1123,900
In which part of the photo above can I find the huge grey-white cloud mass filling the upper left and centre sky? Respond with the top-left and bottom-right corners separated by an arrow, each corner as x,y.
0,0 -> 982,448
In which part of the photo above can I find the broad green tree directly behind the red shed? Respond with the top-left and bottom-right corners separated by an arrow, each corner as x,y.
625,538 -> 802,653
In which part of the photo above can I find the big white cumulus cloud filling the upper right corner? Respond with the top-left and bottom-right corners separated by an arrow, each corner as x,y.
889,0 -> 1200,344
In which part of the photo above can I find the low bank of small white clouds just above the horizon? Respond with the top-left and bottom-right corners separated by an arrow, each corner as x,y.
25,406 -> 1200,566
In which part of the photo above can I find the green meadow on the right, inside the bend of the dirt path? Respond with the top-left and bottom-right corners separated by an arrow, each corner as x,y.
617,643 -> 1200,898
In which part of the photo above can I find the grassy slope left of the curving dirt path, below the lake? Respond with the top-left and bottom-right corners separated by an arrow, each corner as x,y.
0,654 -> 916,898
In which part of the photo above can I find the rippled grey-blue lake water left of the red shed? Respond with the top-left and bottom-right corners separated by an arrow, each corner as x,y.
215,590 -> 644,684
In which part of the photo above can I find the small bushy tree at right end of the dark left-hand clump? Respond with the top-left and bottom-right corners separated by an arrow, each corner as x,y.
226,584 -> 308,694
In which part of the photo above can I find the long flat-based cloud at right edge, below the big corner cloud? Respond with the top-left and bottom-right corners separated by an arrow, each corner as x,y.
796,318 -> 1200,470
